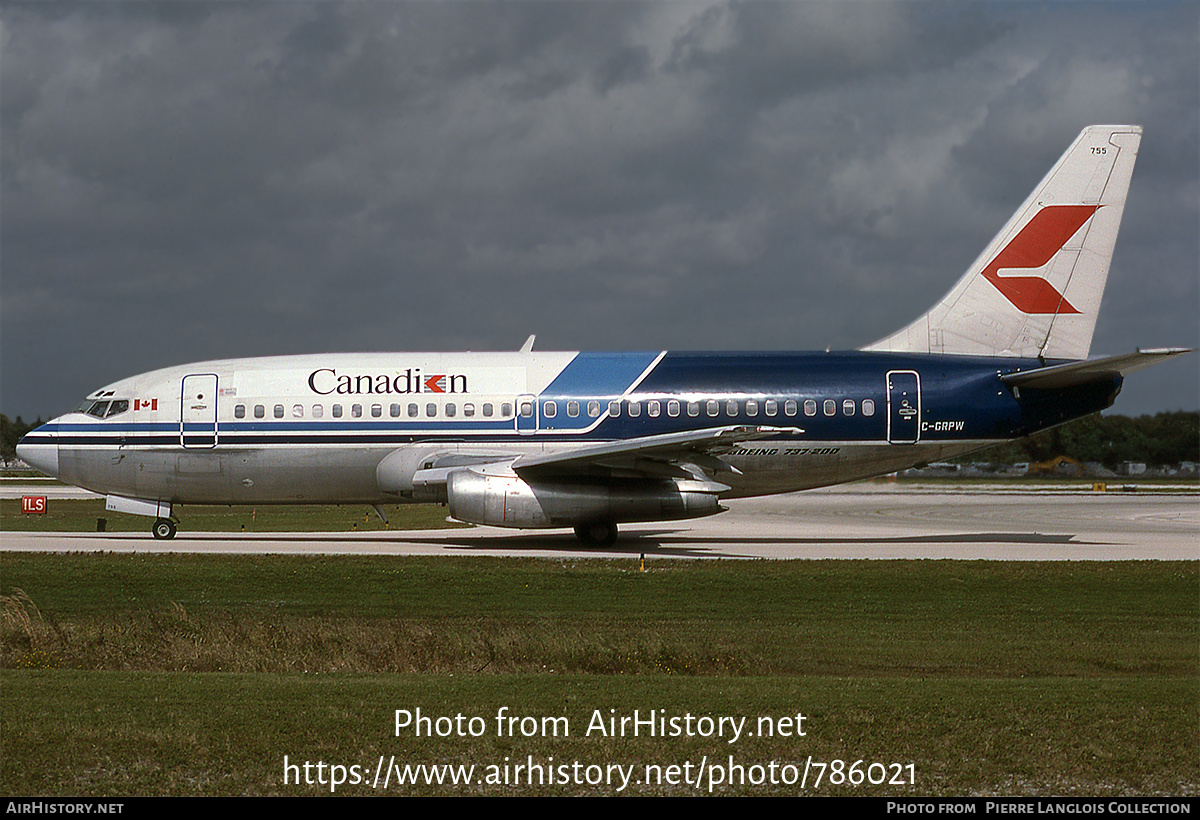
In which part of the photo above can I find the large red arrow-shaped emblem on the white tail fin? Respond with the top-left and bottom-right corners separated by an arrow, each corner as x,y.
983,205 -> 1099,313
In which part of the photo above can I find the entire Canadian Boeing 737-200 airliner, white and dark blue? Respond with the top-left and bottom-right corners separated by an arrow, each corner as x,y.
17,126 -> 1187,545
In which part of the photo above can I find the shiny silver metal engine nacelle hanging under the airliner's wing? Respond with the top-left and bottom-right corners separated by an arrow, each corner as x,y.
446,469 -> 728,528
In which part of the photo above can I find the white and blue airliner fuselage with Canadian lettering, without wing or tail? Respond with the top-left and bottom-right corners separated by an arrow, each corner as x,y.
22,352 -> 1120,504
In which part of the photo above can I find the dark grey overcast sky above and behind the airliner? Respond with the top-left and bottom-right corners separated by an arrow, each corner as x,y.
0,0 -> 1200,419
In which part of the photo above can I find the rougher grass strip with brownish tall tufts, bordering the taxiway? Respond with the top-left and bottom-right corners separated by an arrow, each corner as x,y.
0,553 -> 1200,677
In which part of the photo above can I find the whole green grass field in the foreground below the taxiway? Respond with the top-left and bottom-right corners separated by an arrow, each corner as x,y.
0,552 -> 1200,795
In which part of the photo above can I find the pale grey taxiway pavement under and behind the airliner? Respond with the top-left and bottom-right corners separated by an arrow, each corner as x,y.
2,483 -> 1200,561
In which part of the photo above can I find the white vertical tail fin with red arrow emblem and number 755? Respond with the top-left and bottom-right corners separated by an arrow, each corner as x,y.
864,125 -> 1141,359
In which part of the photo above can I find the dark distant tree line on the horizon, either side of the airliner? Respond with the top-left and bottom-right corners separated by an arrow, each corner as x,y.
0,412 -> 1200,469
